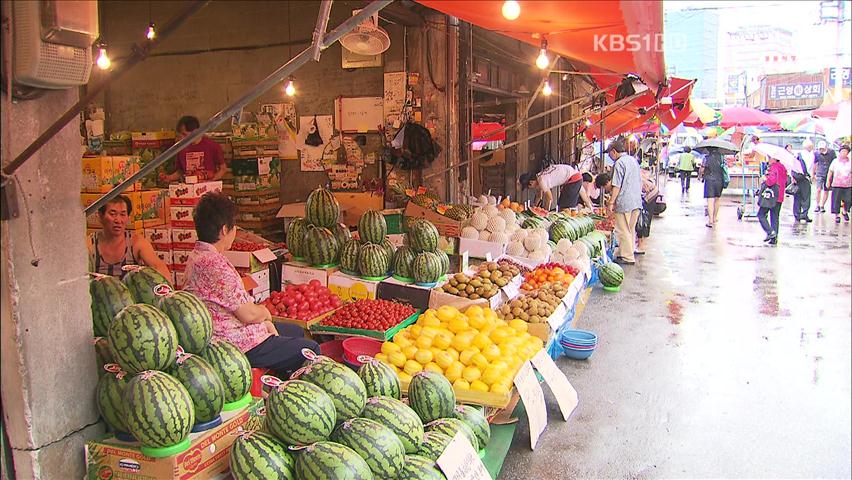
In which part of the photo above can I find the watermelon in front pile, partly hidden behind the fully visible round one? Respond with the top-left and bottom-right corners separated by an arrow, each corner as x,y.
294,357 -> 367,422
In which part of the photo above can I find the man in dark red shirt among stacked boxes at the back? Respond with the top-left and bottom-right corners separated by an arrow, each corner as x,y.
160,116 -> 228,182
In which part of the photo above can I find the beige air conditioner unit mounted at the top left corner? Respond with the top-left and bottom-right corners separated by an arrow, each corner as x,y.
12,0 -> 98,89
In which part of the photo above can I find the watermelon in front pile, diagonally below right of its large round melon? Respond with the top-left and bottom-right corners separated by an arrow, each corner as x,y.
331,418 -> 405,478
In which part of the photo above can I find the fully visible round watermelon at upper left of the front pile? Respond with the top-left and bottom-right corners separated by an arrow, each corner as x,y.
266,380 -> 337,445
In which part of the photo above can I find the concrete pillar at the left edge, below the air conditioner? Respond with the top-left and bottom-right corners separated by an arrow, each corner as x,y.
0,32 -> 103,479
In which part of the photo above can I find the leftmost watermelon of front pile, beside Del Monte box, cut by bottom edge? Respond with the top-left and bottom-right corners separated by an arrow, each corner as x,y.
230,432 -> 296,480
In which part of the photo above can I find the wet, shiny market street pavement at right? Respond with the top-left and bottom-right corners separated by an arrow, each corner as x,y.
500,181 -> 852,480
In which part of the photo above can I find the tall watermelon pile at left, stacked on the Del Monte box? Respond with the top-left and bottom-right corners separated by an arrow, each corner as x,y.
89,267 -> 251,448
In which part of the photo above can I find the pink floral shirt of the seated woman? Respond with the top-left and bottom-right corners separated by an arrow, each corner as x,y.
184,241 -> 270,352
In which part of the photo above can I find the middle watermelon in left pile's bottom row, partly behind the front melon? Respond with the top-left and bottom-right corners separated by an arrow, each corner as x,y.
169,353 -> 225,423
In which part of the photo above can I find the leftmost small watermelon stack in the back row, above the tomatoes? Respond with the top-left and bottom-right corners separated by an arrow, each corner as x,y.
287,188 -> 352,267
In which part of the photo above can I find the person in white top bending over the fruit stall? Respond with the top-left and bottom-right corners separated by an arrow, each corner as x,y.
520,163 -> 592,210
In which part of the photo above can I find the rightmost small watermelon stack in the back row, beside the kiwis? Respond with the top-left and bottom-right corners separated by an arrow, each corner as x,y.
393,219 -> 450,286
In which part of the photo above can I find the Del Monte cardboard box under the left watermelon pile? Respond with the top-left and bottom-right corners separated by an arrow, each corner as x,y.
85,400 -> 263,480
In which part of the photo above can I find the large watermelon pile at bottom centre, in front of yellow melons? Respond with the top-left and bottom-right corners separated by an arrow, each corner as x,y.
230,356 -> 491,480
